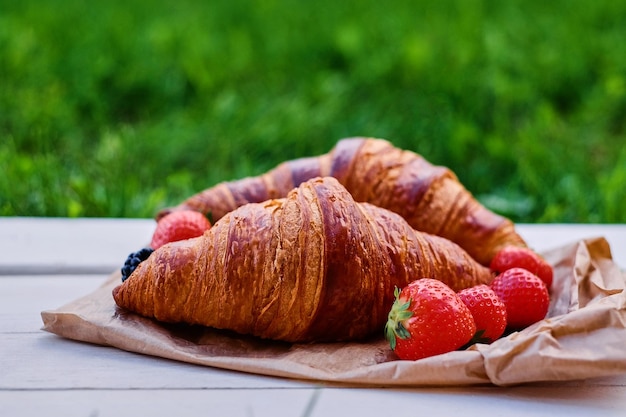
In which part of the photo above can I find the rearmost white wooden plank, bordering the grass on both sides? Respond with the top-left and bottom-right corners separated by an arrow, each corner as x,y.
0,217 -> 626,275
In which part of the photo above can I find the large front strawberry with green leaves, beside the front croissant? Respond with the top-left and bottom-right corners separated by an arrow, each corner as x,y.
385,278 -> 476,360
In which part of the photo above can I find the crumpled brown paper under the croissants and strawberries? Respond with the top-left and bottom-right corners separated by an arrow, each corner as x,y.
42,238 -> 626,386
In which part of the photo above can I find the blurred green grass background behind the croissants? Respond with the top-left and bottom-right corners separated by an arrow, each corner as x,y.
0,0 -> 626,223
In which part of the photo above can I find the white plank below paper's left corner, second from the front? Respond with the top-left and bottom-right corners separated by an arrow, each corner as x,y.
0,332 -> 317,390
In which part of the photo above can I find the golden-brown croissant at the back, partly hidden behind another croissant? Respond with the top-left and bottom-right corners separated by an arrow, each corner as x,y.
157,138 -> 526,265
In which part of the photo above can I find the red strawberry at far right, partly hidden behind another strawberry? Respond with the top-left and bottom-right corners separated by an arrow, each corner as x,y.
489,246 -> 554,288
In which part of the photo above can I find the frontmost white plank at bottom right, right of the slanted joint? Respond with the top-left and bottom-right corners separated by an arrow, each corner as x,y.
311,386 -> 626,417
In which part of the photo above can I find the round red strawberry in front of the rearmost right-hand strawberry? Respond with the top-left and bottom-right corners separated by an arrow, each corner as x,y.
491,268 -> 550,329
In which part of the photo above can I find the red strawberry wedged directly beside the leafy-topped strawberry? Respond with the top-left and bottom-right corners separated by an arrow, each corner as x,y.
457,284 -> 506,343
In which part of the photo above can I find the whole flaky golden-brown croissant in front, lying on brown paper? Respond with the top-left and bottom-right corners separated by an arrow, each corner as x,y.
113,177 -> 493,342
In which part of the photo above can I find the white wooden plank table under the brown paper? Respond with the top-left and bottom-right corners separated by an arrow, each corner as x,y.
0,218 -> 626,417
